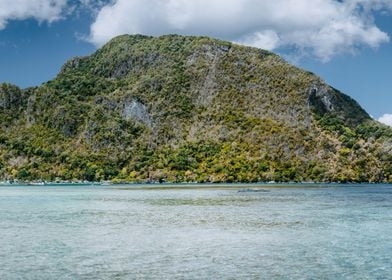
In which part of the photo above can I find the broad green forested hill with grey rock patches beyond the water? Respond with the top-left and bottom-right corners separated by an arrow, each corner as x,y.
0,35 -> 392,182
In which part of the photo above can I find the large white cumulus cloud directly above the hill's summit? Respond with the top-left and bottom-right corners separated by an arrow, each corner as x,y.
89,0 -> 392,61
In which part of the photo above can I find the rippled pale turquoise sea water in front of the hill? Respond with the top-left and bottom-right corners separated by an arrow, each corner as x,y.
0,185 -> 392,279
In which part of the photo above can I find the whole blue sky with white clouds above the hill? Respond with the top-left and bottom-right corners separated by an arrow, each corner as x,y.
0,0 -> 392,126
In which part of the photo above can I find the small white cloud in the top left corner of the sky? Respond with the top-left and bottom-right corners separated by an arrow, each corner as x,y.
0,0 -> 67,30
